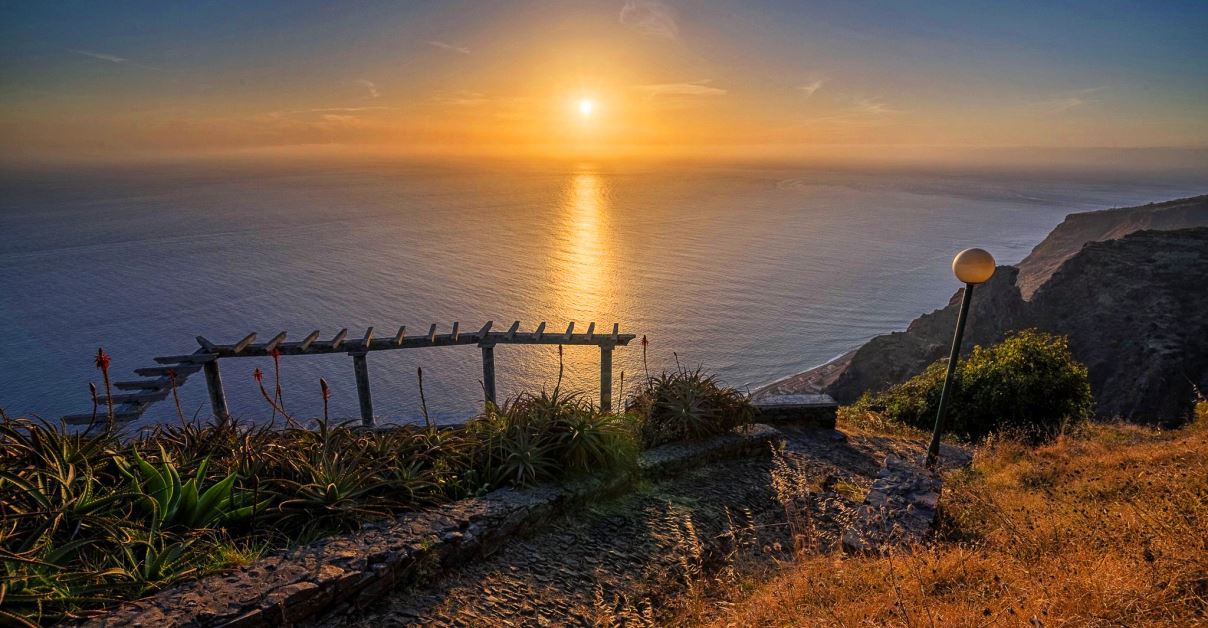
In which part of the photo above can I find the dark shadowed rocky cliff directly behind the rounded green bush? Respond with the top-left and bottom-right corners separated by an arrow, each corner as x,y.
826,218 -> 1208,424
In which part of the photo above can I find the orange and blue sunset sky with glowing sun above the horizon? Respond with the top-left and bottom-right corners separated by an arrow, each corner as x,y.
0,0 -> 1208,158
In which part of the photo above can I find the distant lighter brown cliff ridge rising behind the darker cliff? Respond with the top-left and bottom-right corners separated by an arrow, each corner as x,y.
1016,196 -> 1208,300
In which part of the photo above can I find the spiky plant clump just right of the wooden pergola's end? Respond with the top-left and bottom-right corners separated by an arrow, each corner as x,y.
626,368 -> 755,447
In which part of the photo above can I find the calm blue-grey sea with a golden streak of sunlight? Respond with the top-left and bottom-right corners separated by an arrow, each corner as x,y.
0,159 -> 1208,425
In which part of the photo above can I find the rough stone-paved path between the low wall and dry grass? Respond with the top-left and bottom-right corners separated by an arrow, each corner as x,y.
315,429 -> 968,627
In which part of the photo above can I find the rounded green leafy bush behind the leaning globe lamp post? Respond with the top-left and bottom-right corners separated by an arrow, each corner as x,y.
853,330 -> 1093,441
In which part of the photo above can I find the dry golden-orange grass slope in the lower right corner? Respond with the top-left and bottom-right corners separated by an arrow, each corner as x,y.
681,403 -> 1208,626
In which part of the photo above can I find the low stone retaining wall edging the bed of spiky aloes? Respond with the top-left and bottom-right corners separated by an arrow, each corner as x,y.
85,425 -> 780,627
